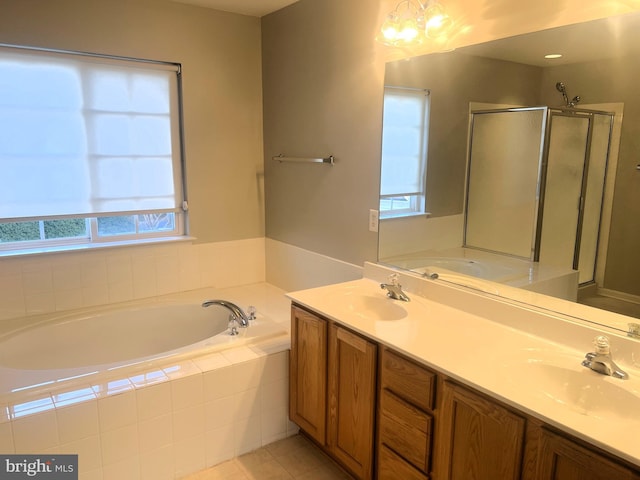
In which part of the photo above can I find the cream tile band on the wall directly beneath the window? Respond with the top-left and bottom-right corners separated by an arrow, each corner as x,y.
0,237 -> 265,321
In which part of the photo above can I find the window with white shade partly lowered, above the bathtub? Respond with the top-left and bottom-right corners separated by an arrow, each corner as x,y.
0,47 -> 186,251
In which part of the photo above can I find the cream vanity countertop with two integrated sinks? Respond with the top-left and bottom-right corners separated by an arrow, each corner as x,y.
287,270 -> 640,466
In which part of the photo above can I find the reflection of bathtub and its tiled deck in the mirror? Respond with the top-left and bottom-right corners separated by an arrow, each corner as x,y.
380,247 -> 578,302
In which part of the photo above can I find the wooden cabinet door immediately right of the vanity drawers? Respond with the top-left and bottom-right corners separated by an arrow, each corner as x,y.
435,381 -> 526,480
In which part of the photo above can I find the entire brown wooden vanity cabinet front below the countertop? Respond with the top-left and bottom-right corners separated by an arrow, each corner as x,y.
289,305 -> 640,480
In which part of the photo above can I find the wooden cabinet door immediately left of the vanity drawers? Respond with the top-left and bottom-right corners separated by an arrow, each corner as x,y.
327,324 -> 376,479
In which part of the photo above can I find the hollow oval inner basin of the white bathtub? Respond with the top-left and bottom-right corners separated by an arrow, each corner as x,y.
0,304 -> 229,370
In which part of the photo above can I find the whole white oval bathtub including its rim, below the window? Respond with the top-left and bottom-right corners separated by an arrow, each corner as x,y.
0,302 -> 286,398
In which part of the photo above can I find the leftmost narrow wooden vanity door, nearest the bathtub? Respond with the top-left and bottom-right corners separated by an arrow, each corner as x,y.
289,306 -> 327,445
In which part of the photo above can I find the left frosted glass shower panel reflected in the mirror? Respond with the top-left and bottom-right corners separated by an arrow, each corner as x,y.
464,107 -> 547,258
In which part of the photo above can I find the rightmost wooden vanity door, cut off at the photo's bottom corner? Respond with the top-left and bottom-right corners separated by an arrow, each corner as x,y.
537,429 -> 640,480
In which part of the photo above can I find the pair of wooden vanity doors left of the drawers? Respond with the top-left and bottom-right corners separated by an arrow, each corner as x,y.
289,305 -> 377,479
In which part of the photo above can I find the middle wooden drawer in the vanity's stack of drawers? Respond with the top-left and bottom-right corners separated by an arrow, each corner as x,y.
379,390 -> 432,472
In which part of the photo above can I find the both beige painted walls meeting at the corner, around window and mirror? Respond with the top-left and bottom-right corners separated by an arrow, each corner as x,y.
0,0 -> 640,270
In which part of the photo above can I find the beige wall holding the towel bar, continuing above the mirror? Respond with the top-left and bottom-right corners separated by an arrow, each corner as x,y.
262,0 -> 640,264
